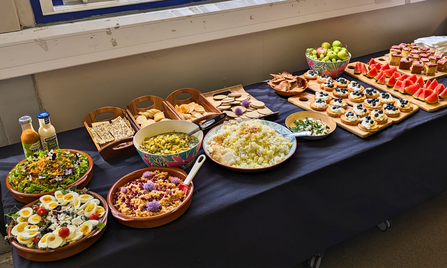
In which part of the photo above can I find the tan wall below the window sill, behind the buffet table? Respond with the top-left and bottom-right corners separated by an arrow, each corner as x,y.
0,0 -> 447,147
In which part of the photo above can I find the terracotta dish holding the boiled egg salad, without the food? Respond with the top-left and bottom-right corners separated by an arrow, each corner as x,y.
8,191 -> 109,262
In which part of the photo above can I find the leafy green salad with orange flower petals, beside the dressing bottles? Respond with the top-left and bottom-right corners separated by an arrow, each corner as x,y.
9,149 -> 89,194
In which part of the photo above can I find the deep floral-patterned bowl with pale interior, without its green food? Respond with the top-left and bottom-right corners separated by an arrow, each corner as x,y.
133,120 -> 203,169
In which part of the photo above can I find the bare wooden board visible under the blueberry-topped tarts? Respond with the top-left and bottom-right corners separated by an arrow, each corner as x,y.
289,92 -> 393,138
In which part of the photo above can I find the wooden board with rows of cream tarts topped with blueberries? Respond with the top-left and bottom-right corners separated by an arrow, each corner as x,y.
288,71 -> 419,138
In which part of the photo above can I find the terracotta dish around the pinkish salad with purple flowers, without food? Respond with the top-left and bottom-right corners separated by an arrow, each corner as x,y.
107,167 -> 194,228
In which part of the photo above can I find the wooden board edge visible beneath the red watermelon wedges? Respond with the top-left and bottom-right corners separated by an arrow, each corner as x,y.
345,62 -> 447,113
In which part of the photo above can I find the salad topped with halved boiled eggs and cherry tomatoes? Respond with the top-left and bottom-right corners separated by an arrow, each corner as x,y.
6,186 -> 106,249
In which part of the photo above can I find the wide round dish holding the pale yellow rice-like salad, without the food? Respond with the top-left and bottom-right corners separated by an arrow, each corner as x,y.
203,119 -> 297,172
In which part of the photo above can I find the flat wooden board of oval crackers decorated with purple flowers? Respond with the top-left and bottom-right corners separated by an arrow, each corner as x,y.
203,85 -> 277,120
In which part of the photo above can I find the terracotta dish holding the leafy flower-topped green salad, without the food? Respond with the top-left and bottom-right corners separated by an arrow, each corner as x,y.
6,149 -> 93,203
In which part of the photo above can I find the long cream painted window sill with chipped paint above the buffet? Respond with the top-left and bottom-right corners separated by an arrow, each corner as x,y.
0,0 -> 409,79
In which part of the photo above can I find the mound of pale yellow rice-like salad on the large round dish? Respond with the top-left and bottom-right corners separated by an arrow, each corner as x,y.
206,120 -> 293,169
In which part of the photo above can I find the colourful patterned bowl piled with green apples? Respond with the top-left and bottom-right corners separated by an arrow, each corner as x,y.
306,40 -> 351,78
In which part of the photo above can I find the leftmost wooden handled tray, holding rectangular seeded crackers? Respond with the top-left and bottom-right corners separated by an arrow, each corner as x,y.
83,106 -> 138,161
